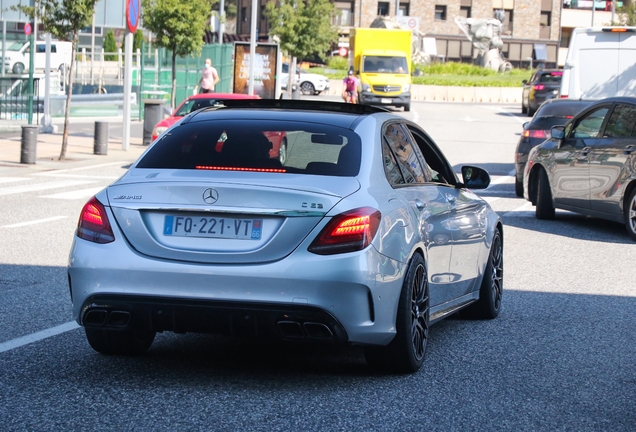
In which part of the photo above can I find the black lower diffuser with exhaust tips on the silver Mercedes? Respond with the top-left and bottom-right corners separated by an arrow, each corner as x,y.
80,294 -> 348,342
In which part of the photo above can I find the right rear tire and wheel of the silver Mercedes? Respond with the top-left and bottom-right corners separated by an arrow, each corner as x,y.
364,254 -> 430,373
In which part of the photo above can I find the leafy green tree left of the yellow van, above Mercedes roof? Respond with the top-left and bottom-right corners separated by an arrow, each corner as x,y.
265,0 -> 338,92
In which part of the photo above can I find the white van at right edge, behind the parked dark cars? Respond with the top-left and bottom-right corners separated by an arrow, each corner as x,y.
560,27 -> 636,100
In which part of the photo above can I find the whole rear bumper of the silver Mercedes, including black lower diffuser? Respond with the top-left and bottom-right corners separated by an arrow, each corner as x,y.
68,238 -> 405,345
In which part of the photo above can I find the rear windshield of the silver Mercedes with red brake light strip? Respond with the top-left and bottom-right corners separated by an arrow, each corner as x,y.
137,120 -> 361,176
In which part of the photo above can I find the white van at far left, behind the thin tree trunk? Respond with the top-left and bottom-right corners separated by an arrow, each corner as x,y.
4,41 -> 73,75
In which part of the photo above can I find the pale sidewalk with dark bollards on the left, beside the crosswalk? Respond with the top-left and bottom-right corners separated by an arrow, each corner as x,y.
0,117 -> 147,171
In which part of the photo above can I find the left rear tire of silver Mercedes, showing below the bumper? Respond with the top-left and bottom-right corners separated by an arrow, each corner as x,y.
84,327 -> 156,355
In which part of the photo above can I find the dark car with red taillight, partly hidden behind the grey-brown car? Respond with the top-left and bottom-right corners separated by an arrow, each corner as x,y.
515,99 -> 593,197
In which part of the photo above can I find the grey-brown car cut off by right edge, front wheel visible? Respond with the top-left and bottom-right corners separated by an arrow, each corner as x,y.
523,98 -> 636,240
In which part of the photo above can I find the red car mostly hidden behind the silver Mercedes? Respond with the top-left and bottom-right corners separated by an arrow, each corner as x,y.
152,93 -> 287,163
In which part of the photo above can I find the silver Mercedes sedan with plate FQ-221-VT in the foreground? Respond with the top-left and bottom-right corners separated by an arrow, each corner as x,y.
68,100 -> 503,372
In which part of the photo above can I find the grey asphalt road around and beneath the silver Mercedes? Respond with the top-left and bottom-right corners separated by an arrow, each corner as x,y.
0,103 -> 636,431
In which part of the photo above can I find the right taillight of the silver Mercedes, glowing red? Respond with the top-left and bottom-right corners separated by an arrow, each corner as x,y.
307,207 -> 382,255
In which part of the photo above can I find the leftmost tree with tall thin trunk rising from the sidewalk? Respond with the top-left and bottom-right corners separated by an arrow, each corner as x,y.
17,0 -> 98,160
